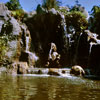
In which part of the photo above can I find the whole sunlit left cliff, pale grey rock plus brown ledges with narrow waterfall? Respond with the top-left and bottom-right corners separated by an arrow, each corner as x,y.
0,4 -> 35,66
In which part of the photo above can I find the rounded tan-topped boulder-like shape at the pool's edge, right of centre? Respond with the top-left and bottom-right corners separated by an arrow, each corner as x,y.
70,65 -> 85,76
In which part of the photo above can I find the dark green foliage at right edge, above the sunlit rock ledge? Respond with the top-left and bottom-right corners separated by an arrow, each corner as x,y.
89,6 -> 100,35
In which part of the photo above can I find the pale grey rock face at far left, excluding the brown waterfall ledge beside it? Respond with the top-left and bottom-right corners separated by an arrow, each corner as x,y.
0,4 -> 21,60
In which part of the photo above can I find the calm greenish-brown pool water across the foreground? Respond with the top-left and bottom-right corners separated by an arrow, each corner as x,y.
0,75 -> 100,100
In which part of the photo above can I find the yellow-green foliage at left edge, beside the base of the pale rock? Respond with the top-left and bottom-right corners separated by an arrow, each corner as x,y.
0,35 -> 8,64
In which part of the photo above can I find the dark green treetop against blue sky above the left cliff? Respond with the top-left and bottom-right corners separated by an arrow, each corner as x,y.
6,0 -> 22,10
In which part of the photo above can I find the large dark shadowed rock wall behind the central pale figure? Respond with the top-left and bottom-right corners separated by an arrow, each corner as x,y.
25,8 -> 68,66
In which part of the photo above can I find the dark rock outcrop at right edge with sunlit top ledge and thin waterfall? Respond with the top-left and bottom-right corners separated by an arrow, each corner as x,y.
77,30 -> 100,75
